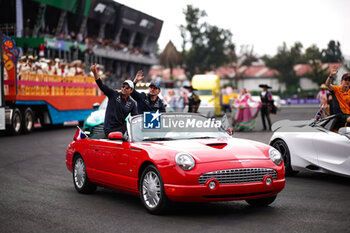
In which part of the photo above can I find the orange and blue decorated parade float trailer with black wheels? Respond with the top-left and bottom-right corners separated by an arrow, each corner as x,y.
2,36 -> 104,135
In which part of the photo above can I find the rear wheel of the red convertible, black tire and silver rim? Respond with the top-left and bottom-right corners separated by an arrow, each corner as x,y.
73,155 -> 97,194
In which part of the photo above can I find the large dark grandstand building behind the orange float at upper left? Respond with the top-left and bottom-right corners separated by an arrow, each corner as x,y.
0,0 -> 163,87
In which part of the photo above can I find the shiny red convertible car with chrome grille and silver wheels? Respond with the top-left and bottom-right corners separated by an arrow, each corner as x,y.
66,113 -> 285,214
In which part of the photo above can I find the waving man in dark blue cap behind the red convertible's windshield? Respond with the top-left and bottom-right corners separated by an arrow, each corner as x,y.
131,70 -> 165,114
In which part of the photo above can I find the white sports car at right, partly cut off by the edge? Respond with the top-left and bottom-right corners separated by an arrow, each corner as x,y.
269,115 -> 350,177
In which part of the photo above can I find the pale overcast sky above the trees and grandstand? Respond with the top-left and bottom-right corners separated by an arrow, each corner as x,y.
116,0 -> 350,57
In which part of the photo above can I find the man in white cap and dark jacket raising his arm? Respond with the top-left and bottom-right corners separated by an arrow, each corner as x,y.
90,64 -> 138,137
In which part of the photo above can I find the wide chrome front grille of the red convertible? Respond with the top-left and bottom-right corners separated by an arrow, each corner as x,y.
198,168 -> 277,185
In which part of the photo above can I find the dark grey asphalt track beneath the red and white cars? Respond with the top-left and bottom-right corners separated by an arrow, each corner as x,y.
0,106 -> 350,233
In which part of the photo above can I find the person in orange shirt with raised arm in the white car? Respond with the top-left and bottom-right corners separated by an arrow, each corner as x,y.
326,67 -> 350,124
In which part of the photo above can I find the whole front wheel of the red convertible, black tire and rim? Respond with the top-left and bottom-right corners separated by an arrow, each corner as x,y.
139,165 -> 170,214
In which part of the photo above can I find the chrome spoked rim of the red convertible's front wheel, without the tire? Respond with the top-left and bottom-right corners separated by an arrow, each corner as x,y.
142,171 -> 161,208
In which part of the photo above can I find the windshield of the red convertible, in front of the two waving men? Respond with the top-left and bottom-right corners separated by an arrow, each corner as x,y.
128,113 -> 230,142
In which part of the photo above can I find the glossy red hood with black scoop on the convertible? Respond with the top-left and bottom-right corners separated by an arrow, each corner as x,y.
138,138 -> 270,163
